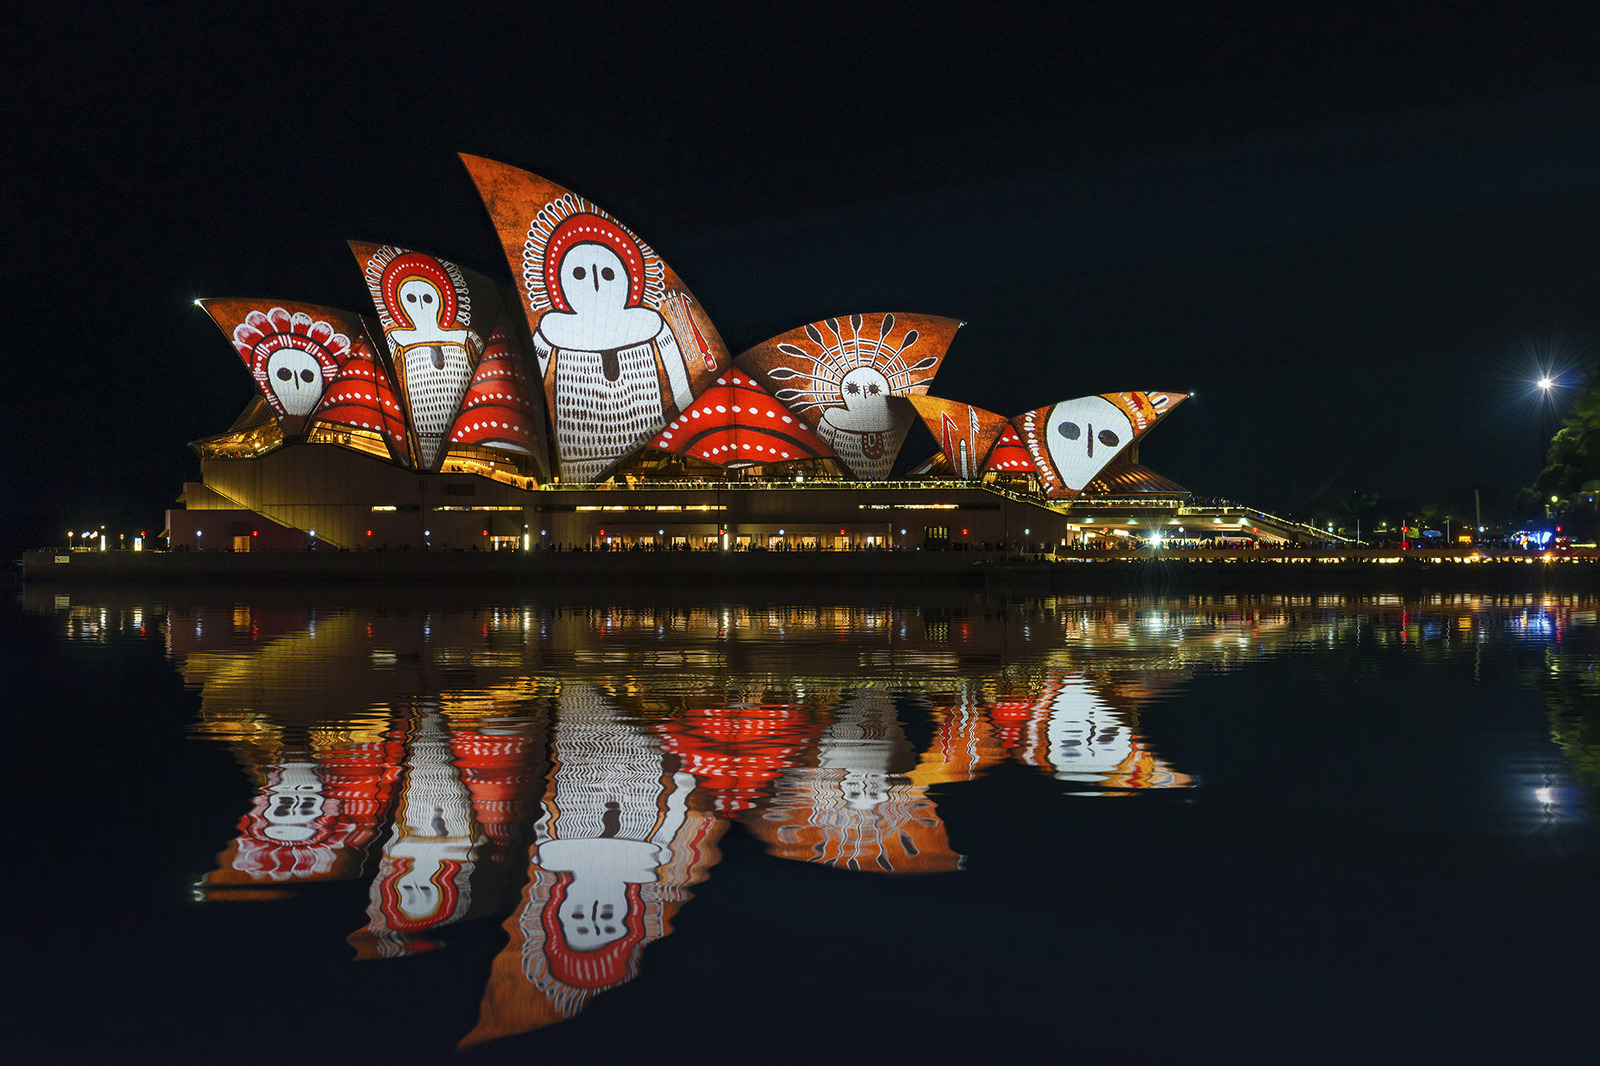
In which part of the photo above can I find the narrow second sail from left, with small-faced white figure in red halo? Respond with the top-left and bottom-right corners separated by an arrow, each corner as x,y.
350,240 -> 490,471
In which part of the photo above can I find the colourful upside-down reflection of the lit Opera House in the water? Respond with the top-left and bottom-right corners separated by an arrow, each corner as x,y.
34,597 -> 1573,1045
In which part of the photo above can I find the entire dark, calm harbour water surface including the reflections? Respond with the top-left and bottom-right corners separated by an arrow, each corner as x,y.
0,587 -> 1600,1063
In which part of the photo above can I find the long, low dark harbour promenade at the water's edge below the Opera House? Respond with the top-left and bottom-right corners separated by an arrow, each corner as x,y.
22,547 -> 1600,592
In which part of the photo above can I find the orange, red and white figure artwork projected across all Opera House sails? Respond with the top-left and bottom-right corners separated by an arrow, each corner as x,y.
195,155 -> 1184,496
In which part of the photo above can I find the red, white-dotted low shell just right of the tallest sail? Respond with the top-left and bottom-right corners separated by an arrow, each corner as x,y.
650,370 -> 834,466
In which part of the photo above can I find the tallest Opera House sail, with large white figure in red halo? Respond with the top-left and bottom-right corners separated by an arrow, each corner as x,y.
461,155 -> 728,483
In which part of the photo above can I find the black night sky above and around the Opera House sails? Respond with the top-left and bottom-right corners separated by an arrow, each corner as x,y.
12,0 -> 1600,538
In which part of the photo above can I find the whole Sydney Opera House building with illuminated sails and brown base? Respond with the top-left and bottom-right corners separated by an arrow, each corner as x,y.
168,155 -> 1187,551
